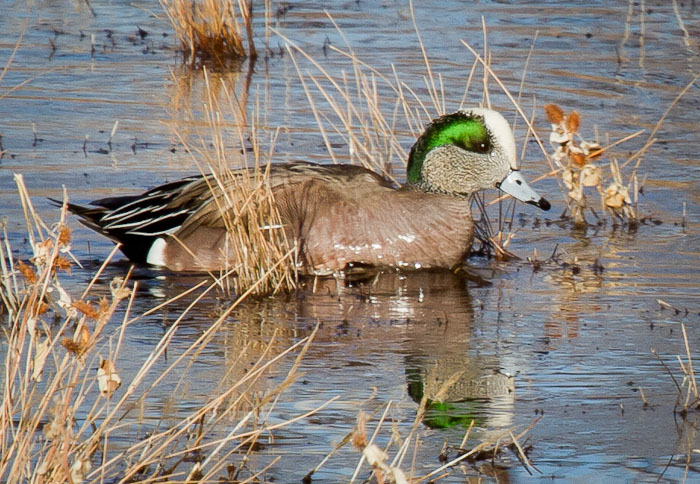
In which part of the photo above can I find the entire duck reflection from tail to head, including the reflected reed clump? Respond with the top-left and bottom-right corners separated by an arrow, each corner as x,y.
98,271 -> 515,430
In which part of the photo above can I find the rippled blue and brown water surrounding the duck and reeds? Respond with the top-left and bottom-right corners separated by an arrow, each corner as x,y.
0,0 -> 700,482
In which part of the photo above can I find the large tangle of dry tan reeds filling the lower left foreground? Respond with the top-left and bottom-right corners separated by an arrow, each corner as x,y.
0,175 -> 329,484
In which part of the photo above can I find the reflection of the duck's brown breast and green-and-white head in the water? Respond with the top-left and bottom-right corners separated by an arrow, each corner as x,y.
290,271 -> 515,428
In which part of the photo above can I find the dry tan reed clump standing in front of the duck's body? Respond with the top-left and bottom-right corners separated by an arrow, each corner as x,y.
175,69 -> 298,294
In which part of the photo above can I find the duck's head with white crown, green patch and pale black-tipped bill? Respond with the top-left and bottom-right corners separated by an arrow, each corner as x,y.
408,108 -> 550,210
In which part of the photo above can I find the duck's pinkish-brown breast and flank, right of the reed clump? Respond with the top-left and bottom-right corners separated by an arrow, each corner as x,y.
281,182 -> 473,273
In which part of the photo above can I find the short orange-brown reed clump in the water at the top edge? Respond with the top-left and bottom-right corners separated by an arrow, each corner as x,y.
160,0 -> 257,65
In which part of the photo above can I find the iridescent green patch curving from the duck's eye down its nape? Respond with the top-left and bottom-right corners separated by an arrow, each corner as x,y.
408,112 -> 491,183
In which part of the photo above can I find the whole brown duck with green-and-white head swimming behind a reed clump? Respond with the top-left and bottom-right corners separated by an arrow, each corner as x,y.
61,108 -> 550,275
